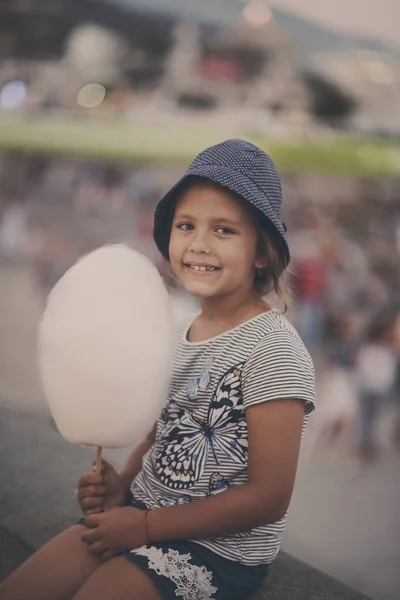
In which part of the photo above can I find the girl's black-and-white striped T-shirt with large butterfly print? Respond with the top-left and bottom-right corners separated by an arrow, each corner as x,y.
132,309 -> 315,565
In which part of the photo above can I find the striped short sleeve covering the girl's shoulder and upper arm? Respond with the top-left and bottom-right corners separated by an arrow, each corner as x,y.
242,329 -> 315,414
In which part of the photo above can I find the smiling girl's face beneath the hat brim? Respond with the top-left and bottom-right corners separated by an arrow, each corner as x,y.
169,182 -> 263,300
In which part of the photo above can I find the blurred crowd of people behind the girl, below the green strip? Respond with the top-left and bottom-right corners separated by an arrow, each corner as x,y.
0,155 -> 400,462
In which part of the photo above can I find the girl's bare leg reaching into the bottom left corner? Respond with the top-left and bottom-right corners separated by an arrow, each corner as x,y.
0,525 -> 104,600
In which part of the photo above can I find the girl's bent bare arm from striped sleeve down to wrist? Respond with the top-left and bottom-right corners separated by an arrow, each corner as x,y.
148,399 -> 304,541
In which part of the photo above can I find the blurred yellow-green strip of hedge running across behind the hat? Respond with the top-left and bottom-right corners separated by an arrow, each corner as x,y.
0,114 -> 400,176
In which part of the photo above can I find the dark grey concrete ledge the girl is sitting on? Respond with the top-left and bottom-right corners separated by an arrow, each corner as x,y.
0,402 -> 367,600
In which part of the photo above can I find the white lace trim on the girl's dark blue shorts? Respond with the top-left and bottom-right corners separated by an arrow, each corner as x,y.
131,546 -> 218,600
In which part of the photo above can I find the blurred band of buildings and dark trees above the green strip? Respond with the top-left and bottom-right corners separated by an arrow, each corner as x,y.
0,0 -> 400,135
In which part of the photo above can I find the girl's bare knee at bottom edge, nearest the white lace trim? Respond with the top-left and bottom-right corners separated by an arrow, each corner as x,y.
73,556 -> 162,600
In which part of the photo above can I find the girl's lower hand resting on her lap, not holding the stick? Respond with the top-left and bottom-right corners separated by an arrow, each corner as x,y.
81,506 -> 147,560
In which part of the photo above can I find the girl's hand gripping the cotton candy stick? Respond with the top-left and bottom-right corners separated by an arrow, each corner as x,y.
77,460 -> 129,516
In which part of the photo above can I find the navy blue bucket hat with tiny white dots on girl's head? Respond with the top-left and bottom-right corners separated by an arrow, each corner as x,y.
153,140 -> 290,267
